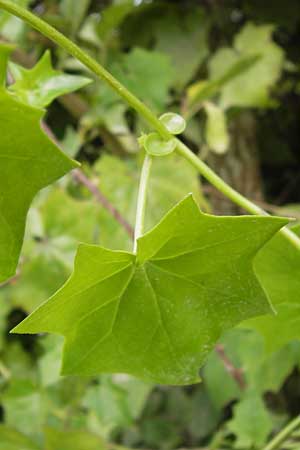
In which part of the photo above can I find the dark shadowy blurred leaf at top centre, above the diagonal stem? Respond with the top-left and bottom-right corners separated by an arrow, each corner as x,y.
121,1 -> 211,91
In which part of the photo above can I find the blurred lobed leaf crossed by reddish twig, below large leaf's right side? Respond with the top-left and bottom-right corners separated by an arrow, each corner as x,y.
202,328 -> 300,410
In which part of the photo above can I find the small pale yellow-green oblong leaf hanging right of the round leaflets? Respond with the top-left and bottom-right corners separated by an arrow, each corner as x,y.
205,102 -> 230,155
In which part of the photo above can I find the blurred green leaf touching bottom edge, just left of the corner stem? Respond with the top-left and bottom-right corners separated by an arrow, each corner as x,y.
228,393 -> 273,449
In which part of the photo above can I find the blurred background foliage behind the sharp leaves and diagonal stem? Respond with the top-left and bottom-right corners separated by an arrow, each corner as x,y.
0,0 -> 300,450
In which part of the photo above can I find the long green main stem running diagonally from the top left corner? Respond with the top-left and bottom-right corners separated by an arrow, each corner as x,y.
0,0 -> 300,250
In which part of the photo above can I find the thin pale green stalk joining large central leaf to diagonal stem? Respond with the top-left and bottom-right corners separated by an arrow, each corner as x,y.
133,154 -> 152,253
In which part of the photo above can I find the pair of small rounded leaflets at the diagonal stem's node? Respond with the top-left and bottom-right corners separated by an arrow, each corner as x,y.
139,113 -> 185,156
